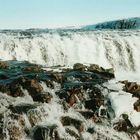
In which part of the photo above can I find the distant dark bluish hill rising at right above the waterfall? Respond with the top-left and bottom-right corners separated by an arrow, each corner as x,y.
81,17 -> 140,30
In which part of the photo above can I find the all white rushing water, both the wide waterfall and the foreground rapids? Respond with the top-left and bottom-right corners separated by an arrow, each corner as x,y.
0,30 -> 140,140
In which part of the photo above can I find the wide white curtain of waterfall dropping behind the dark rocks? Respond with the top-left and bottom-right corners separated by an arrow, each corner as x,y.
0,30 -> 140,71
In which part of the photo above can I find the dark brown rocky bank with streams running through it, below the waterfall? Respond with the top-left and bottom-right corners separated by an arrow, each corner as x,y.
0,61 -> 140,140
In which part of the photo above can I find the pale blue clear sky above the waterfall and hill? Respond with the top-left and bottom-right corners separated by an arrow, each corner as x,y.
0,0 -> 140,29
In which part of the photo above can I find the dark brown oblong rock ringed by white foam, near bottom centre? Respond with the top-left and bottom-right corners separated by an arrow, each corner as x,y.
61,116 -> 84,132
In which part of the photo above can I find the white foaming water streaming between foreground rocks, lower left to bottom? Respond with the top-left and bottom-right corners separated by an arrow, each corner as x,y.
0,83 -> 132,140
